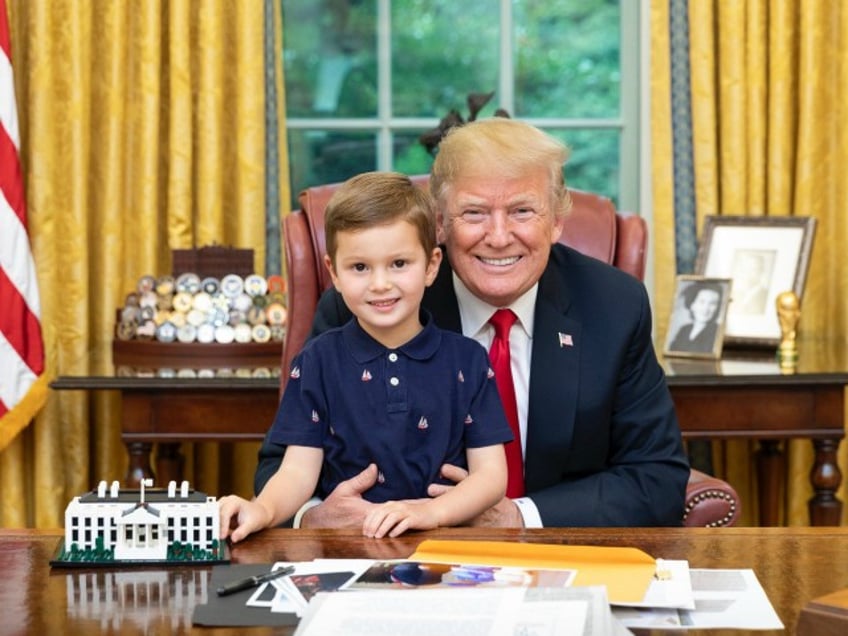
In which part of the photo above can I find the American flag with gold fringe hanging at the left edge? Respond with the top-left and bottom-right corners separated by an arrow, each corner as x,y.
0,0 -> 47,450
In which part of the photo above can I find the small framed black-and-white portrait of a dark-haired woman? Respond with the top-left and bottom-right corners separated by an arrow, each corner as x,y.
663,275 -> 731,360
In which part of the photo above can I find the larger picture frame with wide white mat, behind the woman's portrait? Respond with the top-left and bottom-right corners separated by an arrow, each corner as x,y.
695,216 -> 816,347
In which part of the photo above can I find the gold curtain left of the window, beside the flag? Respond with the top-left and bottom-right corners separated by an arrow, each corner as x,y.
0,0 -> 288,527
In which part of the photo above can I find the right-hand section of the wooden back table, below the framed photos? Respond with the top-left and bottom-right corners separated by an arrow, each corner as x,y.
664,339 -> 848,526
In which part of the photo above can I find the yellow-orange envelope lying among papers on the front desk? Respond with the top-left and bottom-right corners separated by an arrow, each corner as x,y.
409,539 -> 656,603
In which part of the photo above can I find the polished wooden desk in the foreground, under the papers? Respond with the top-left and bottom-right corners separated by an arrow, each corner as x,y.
0,528 -> 848,636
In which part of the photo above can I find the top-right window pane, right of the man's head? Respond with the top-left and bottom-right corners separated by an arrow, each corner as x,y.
513,0 -> 621,118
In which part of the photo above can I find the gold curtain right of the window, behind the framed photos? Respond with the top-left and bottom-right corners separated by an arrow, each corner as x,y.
651,0 -> 848,525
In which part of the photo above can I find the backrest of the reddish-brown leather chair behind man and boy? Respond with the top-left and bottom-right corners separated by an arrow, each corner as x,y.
281,175 -> 648,380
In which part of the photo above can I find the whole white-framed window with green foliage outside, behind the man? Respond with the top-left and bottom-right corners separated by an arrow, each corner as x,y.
280,0 -> 640,209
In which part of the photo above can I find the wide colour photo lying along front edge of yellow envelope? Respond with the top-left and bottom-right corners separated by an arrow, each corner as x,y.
346,561 -> 577,589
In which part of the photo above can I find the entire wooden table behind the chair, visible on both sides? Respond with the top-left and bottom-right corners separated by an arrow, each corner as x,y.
50,340 -> 848,526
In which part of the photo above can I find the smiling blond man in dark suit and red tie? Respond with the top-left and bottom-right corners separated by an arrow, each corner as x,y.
256,118 -> 689,527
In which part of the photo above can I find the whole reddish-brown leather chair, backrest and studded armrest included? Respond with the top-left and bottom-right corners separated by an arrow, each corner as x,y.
280,175 -> 740,527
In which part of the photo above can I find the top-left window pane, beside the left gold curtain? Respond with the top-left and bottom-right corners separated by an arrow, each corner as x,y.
283,0 -> 377,117
